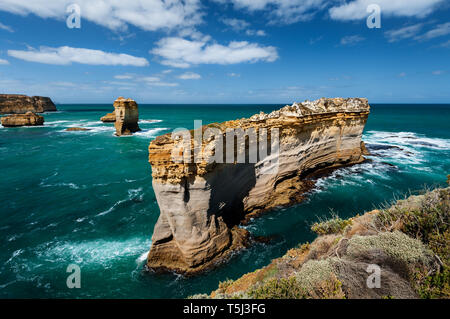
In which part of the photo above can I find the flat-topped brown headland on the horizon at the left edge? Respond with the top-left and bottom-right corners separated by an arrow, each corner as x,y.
0,94 -> 56,114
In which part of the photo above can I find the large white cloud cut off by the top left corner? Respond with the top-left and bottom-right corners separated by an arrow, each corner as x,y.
0,0 -> 202,31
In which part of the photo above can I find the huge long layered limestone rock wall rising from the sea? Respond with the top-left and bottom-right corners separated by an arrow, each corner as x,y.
147,98 -> 370,274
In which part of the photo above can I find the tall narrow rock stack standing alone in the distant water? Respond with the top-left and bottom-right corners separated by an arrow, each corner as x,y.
114,97 -> 141,136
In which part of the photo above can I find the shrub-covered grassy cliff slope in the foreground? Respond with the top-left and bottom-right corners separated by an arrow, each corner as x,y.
195,182 -> 450,299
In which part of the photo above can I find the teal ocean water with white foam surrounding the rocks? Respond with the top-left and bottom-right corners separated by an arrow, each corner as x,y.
0,104 -> 450,298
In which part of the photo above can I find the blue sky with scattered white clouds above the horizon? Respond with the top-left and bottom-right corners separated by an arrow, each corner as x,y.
0,0 -> 450,103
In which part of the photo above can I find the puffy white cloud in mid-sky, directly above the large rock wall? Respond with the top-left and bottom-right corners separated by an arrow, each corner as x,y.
150,37 -> 278,68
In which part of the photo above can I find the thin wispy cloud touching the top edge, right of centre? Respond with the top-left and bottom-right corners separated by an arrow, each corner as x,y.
215,0 -> 327,23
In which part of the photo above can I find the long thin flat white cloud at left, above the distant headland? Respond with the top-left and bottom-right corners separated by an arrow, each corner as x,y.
8,46 -> 149,66
